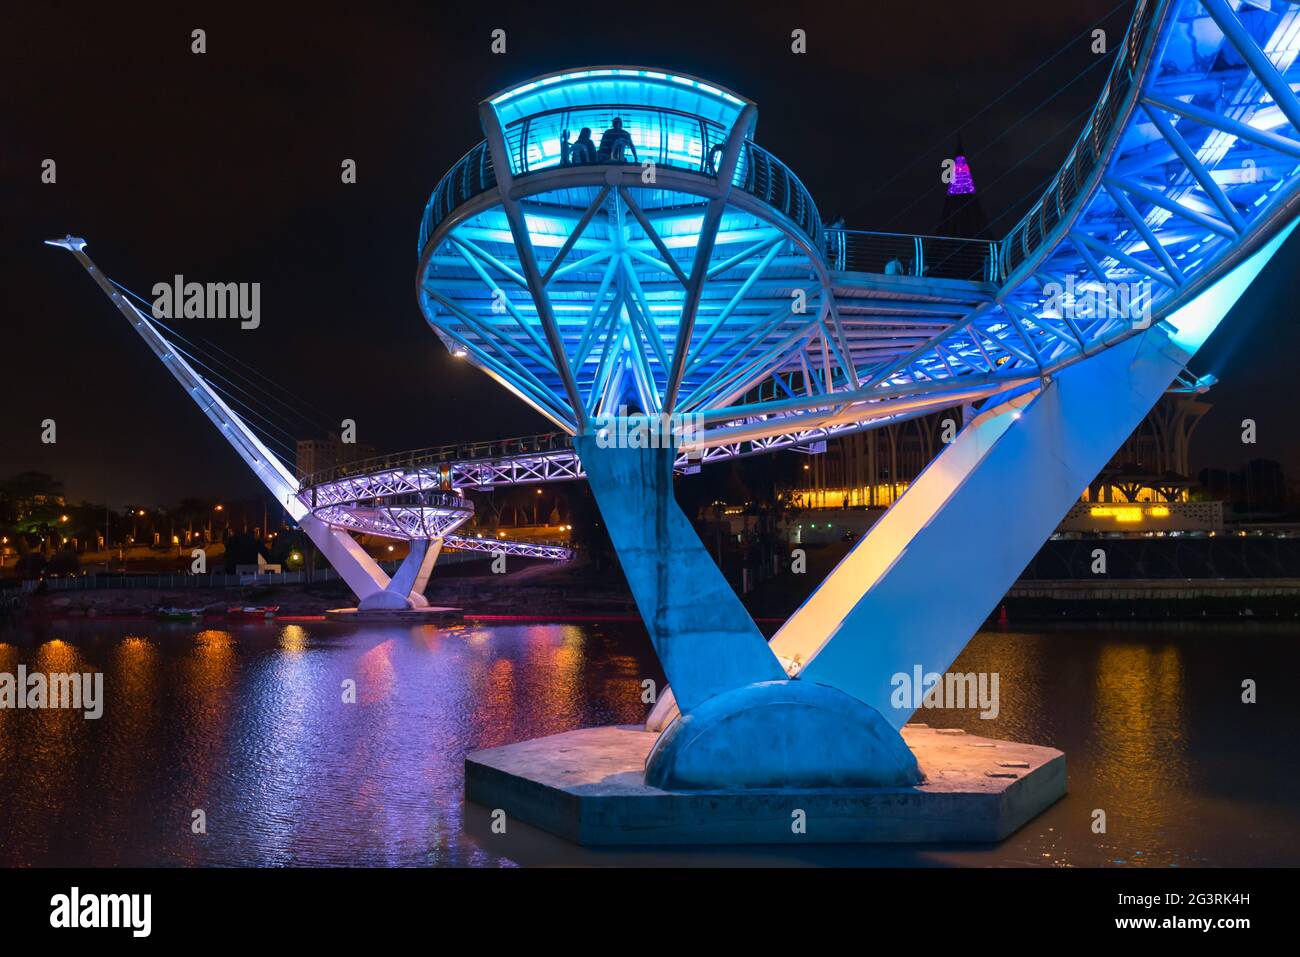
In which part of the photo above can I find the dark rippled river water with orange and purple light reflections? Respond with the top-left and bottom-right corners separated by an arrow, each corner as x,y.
0,622 -> 1300,866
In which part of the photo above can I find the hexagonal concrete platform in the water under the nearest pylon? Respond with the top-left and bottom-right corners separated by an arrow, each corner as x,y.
465,726 -> 1066,845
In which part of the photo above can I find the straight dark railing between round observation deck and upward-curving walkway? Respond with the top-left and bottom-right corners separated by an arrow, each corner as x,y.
824,229 -> 1000,282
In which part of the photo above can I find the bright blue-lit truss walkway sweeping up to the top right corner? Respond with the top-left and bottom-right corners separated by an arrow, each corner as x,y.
868,0 -> 1300,384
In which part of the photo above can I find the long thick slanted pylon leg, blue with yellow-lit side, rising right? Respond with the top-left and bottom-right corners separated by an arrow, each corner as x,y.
772,221 -> 1295,728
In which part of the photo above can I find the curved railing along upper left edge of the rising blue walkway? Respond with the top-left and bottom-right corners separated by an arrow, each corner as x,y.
998,0 -> 1156,280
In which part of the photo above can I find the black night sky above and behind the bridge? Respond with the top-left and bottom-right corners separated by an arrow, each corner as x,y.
0,0 -> 1300,505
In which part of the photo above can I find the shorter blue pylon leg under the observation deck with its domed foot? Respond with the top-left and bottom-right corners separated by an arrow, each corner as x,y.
575,419 -> 920,791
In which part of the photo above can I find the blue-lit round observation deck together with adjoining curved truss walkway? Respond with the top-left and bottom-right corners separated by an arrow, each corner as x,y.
417,0 -> 1300,450
